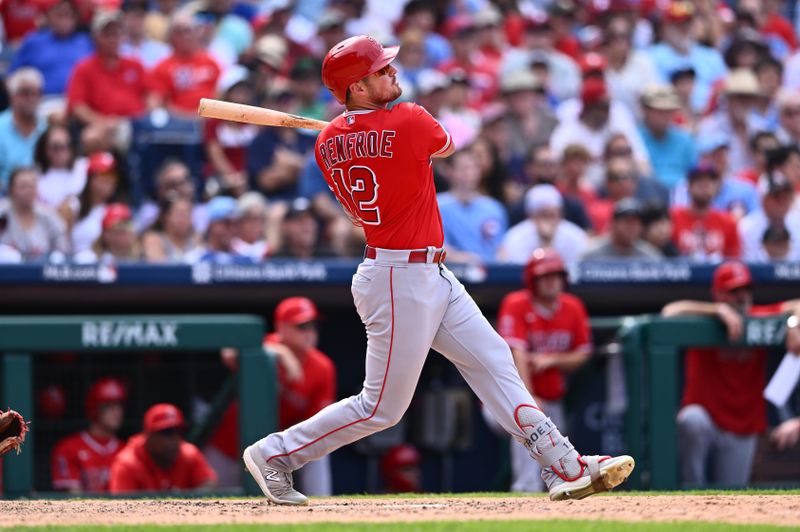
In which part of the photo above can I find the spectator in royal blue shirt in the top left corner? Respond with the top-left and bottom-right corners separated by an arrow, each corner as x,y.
9,0 -> 94,96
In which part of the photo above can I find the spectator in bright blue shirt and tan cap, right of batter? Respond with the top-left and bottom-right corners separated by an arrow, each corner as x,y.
639,85 -> 697,188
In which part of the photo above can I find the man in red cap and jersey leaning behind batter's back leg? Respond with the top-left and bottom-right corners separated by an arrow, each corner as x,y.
207,297 -> 336,496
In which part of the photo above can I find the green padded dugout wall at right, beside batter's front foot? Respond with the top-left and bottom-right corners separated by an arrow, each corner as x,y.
622,316 -> 786,490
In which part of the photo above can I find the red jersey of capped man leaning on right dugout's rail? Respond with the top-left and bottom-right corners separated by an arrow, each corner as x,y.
681,303 -> 783,434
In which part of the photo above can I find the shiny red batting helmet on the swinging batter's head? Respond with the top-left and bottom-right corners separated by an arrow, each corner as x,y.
322,35 -> 400,103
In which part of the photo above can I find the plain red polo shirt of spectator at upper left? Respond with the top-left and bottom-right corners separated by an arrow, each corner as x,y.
67,54 -> 147,117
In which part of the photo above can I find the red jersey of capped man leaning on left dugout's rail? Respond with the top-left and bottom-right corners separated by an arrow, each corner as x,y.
211,333 -> 336,458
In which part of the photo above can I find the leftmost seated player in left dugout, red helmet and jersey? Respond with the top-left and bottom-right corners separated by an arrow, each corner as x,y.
51,378 -> 127,494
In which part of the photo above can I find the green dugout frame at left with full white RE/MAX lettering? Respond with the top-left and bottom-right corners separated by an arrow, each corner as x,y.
0,315 -> 278,497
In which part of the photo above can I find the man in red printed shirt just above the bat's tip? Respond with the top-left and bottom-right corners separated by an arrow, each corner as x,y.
148,10 -> 221,118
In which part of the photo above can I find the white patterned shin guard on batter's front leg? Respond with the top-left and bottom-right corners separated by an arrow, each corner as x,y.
516,405 -> 582,478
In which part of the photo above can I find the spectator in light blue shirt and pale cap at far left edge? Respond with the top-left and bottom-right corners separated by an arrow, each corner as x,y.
0,68 -> 47,189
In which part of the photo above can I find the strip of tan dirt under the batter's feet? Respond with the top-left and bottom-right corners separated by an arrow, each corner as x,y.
0,495 -> 800,527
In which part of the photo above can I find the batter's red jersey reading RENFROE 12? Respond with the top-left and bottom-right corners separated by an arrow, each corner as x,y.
314,103 -> 451,249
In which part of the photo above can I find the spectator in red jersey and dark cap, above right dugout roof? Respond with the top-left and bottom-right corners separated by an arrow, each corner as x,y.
671,165 -> 741,262
